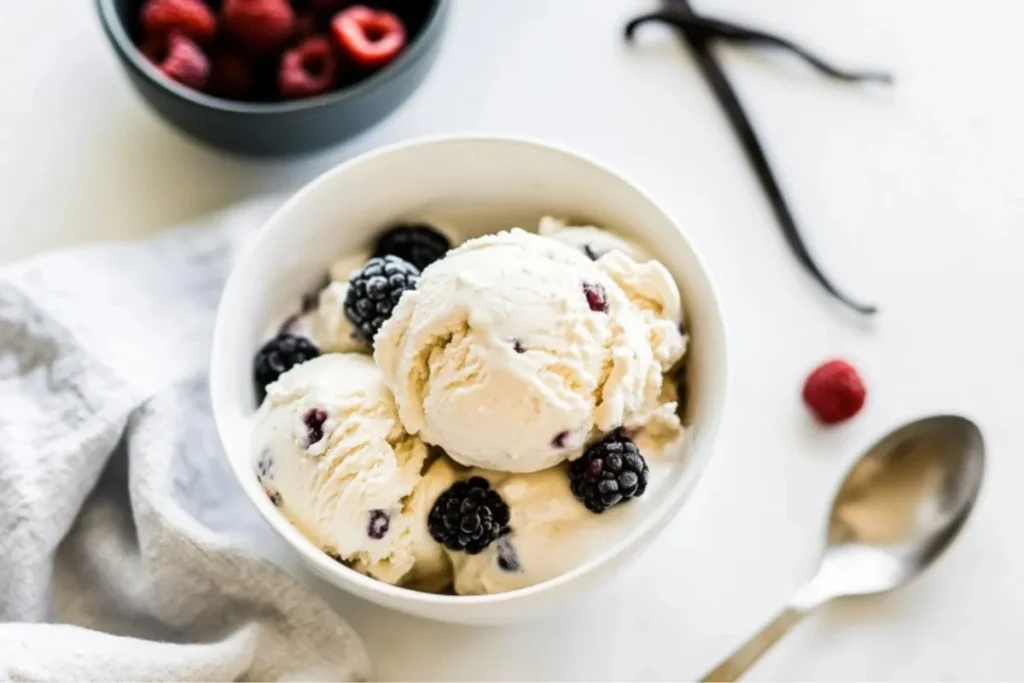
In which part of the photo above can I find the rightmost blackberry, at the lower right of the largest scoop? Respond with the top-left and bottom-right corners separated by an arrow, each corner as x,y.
569,429 -> 650,513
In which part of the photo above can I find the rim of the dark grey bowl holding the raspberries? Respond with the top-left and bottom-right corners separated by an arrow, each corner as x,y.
95,0 -> 451,116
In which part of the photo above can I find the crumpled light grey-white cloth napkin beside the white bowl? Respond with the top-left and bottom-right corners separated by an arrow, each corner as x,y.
0,200 -> 369,681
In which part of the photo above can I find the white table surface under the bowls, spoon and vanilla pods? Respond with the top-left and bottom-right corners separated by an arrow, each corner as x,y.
0,0 -> 1024,680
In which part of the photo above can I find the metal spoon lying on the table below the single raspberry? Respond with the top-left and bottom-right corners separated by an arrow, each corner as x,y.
702,416 -> 985,681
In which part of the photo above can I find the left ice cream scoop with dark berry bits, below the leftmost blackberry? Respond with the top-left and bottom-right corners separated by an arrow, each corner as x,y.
253,353 -> 434,584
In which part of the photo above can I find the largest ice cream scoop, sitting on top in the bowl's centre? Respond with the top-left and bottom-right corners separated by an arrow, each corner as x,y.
375,229 -> 681,472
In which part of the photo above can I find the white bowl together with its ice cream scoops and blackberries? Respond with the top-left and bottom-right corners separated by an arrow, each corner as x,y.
211,137 -> 726,624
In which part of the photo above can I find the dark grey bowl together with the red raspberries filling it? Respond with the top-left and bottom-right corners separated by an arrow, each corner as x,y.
96,0 -> 449,156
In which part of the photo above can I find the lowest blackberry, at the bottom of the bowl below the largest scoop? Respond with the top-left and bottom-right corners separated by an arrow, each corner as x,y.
427,477 -> 510,555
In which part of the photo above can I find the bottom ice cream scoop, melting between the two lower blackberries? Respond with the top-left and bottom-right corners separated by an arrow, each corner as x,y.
446,466 -> 638,595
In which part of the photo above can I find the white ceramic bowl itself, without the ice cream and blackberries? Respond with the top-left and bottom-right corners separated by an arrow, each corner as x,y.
210,137 -> 726,624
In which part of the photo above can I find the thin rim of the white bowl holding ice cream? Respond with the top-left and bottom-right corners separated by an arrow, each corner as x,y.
210,132 -> 729,614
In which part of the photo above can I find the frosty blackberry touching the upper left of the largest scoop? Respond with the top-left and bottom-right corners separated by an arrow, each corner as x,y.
345,256 -> 420,345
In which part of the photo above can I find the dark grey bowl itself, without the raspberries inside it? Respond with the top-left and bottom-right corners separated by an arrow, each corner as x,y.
96,0 -> 450,156
